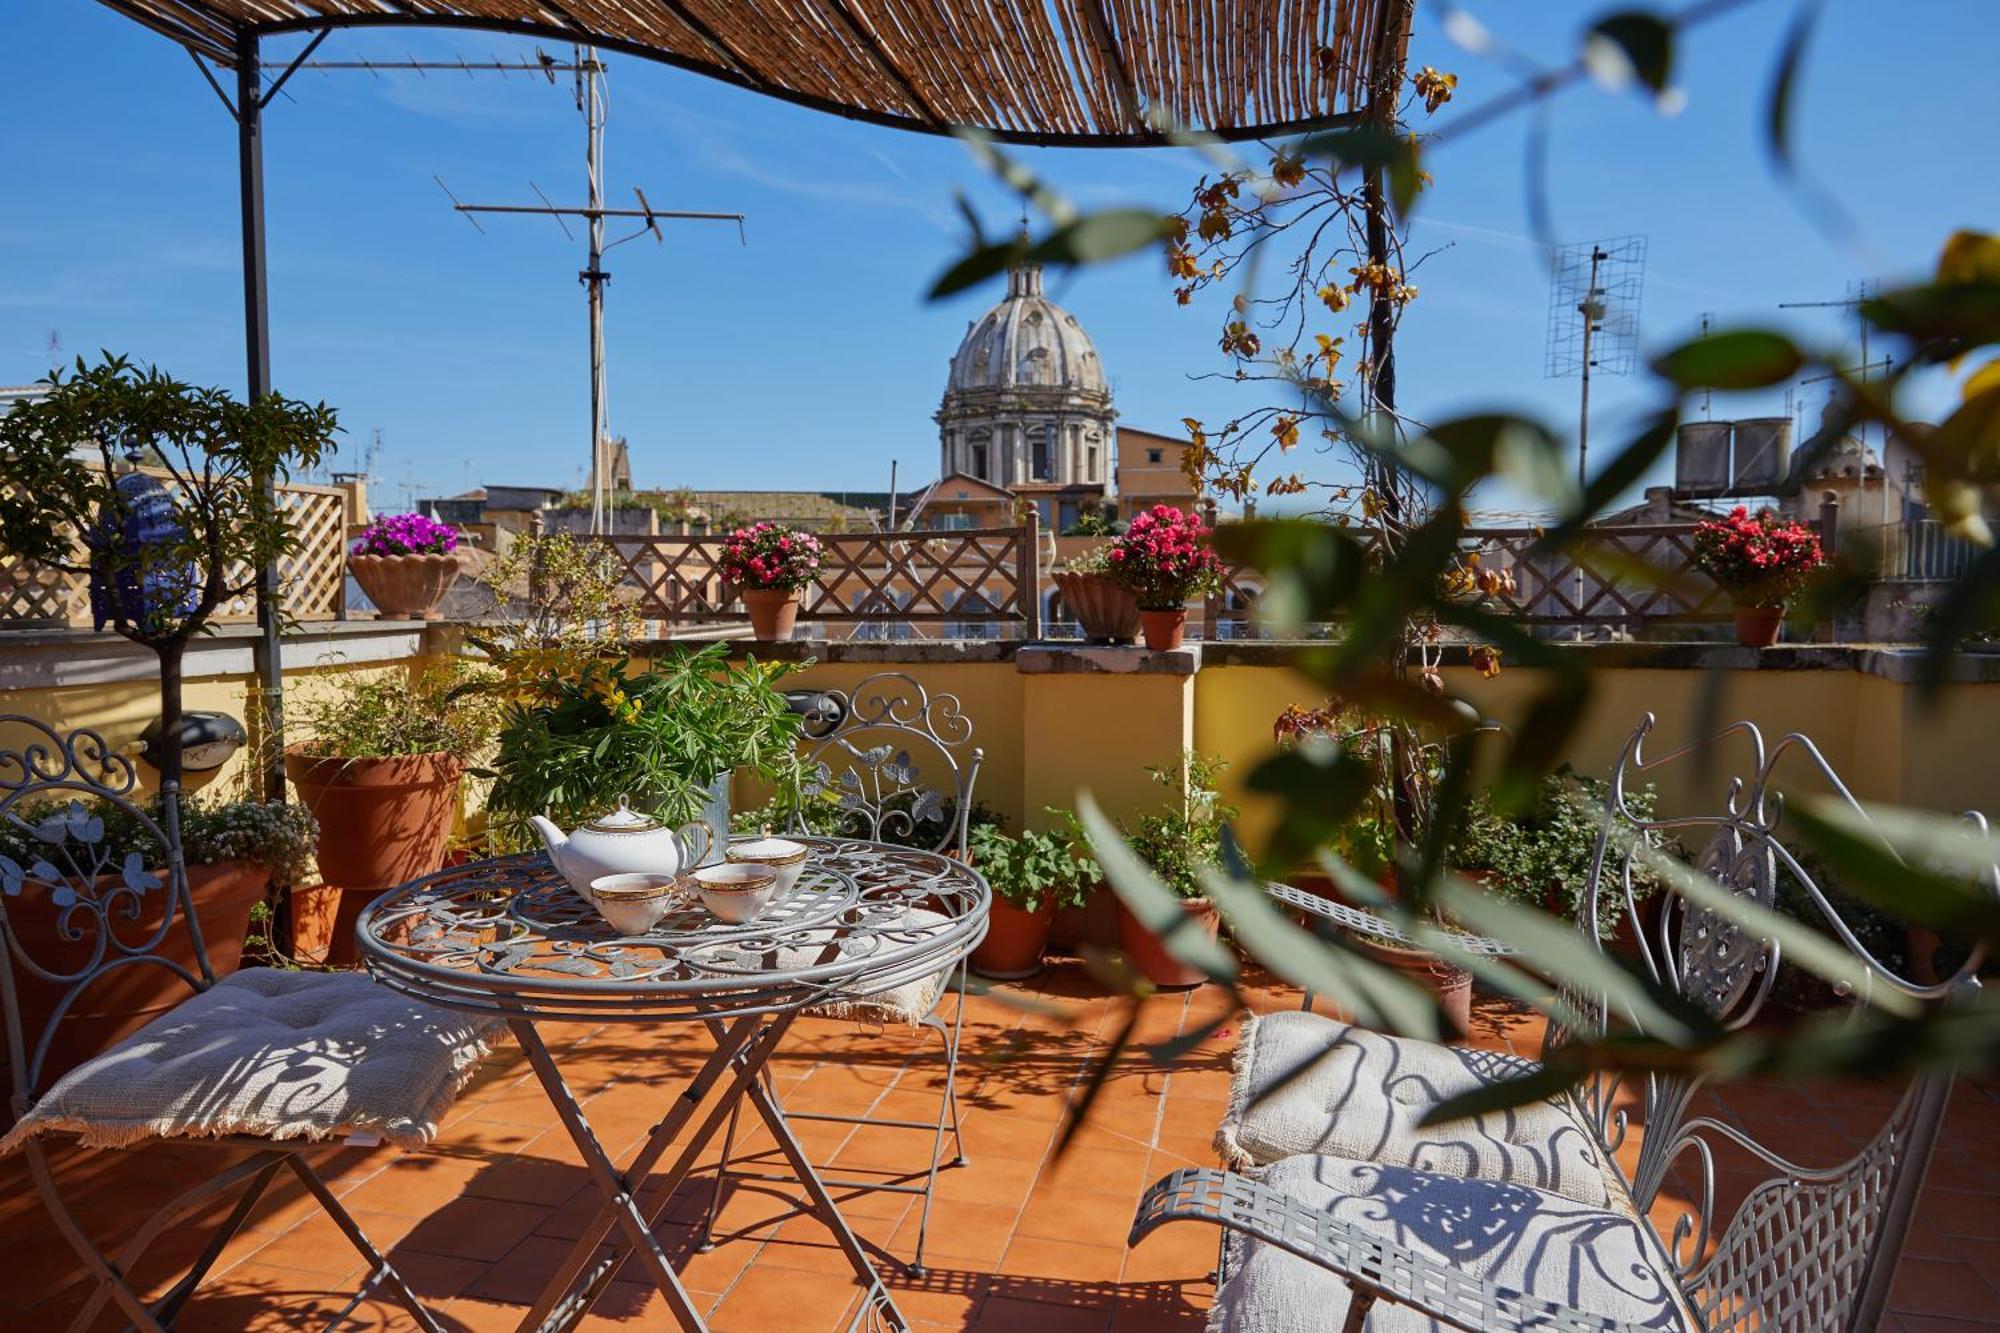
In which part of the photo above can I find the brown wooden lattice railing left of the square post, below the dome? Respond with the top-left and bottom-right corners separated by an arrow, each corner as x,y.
598,518 -> 1042,638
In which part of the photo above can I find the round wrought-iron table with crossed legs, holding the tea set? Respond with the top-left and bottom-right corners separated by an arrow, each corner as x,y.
356,837 -> 992,1333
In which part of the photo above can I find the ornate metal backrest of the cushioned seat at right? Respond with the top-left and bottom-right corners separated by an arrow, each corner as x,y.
1548,715 -> 1992,1333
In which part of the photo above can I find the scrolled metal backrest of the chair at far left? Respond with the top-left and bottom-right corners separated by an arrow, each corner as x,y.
0,715 -> 216,1119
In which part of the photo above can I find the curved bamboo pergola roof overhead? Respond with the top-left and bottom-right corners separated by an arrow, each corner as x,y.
104,0 -> 1408,146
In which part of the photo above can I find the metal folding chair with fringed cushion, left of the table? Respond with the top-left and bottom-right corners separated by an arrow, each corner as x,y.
0,717 -> 488,1333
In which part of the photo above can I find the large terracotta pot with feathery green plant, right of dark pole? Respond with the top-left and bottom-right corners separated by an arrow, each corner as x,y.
284,660 -> 496,963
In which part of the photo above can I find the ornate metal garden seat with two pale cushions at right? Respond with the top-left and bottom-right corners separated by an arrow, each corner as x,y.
1132,715 -> 1994,1333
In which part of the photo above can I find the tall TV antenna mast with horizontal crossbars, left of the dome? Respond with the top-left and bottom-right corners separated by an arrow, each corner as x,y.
434,46 -> 748,532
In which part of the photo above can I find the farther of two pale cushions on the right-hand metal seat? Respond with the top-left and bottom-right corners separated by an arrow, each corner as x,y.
1216,1011 -> 1630,1211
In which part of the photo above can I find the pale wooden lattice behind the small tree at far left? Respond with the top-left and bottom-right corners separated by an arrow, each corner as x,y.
0,468 -> 348,626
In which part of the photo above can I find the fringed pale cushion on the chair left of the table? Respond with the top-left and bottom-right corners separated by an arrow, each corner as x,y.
0,967 -> 498,1153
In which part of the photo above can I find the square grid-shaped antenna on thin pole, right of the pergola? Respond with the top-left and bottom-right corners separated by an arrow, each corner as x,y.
1544,236 -> 1646,490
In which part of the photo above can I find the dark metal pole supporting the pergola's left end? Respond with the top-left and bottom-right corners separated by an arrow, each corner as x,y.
236,32 -> 284,801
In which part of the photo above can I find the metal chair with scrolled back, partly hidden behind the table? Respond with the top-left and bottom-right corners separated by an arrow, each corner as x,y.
704,671 -> 986,1273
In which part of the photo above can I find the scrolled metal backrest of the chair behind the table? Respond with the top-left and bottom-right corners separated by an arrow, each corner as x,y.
792,671 -> 986,851
